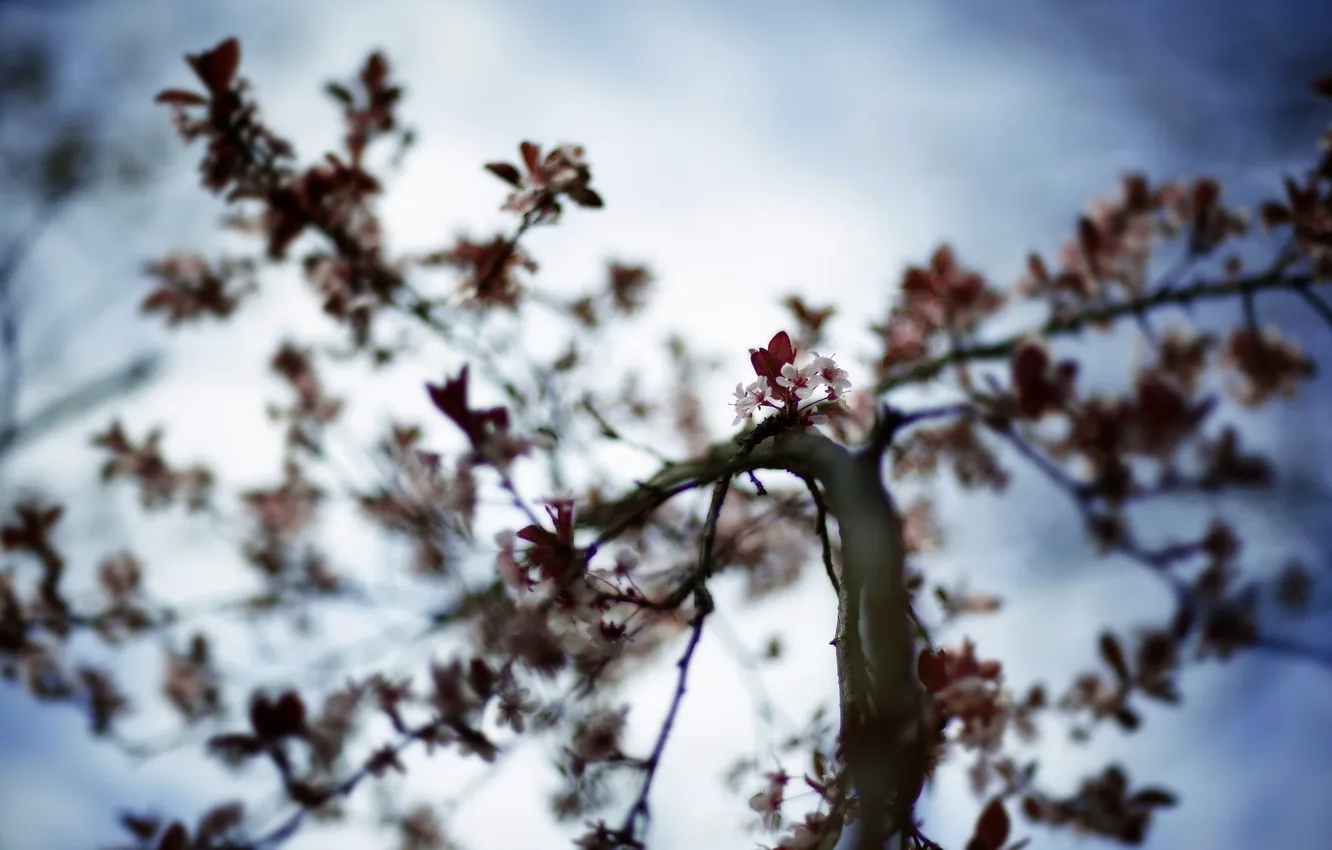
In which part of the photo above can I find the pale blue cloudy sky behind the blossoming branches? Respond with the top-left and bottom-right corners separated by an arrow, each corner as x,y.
0,0 -> 1332,850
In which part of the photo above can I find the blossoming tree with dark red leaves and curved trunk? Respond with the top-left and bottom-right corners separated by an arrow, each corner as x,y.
0,40 -> 1332,850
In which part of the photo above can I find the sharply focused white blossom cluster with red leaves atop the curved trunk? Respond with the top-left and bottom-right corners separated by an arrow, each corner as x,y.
731,330 -> 851,425
